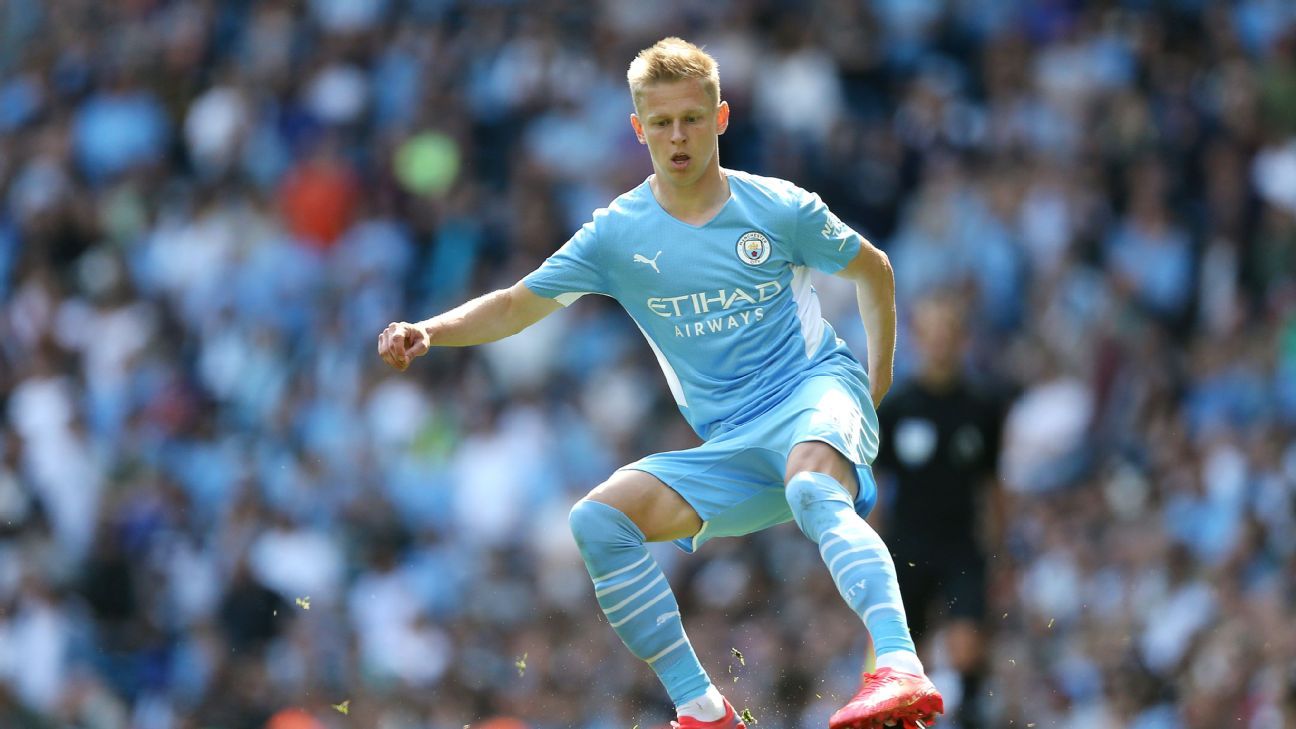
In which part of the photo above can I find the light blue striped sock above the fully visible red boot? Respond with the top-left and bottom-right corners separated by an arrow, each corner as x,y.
787,471 -> 914,656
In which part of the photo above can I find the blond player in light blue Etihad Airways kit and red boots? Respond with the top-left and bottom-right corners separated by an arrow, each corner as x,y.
378,38 -> 943,729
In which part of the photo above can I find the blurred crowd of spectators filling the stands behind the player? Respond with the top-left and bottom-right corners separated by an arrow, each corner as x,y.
0,0 -> 1296,729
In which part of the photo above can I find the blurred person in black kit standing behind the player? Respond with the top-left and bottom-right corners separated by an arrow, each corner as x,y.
874,296 -> 1004,729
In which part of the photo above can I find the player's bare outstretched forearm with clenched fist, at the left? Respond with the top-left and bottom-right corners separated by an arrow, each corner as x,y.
378,281 -> 562,371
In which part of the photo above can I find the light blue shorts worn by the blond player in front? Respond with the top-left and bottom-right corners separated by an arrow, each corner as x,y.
622,376 -> 877,553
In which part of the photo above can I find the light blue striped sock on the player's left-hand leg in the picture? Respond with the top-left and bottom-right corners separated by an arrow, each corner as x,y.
569,499 -> 712,706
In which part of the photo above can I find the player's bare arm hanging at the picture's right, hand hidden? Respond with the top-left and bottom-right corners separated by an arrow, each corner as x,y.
837,237 -> 896,407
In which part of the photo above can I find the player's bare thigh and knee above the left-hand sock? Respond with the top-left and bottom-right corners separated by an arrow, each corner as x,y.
584,470 -> 702,542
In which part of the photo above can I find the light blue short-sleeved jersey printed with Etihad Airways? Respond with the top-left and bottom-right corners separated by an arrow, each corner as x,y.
524,170 -> 877,443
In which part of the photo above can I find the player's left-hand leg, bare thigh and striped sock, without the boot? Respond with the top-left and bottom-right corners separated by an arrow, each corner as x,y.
570,471 -> 726,721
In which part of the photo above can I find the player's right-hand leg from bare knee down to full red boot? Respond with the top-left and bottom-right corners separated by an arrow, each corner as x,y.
785,441 -> 942,728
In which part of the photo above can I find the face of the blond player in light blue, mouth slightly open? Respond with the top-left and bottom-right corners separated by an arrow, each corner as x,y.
630,79 -> 728,187
